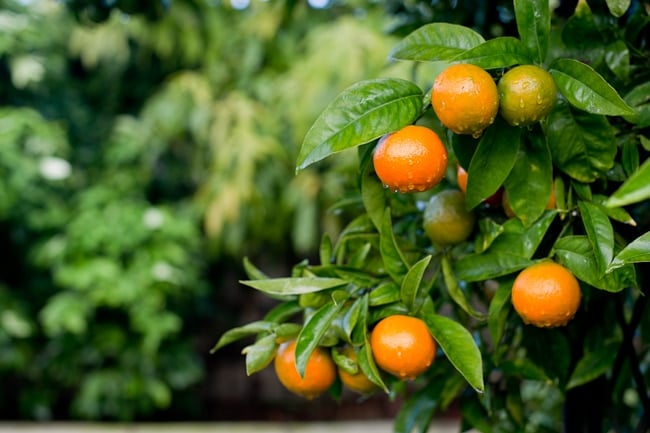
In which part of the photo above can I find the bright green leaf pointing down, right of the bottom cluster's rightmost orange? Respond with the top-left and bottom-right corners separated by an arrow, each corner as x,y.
421,307 -> 485,392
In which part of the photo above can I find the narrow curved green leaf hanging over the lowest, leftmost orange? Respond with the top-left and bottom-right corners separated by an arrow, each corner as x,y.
296,301 -> 345,377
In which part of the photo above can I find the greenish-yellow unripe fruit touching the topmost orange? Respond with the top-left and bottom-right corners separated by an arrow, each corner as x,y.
497,65 -> 557,126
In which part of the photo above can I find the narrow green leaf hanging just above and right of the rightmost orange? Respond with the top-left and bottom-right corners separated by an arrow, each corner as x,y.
578,201 -> 614,275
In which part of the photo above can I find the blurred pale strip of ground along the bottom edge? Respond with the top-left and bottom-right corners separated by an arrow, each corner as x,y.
0,420 -> 460,433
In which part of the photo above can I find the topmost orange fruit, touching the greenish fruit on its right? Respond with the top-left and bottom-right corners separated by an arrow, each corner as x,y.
431,63 -> 499,138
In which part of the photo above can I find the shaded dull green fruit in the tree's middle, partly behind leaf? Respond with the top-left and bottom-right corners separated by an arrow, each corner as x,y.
422,189 -> 476,247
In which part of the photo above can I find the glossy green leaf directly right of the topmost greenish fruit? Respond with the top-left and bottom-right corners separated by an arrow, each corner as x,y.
549,59 -> 635,116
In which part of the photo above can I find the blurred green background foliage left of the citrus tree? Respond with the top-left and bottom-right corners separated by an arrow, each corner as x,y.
0,0 -> 540,420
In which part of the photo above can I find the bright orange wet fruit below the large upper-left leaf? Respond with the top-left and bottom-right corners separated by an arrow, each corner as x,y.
373,125 -> 447,193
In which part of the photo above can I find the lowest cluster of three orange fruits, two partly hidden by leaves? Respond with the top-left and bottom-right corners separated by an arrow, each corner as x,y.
274,314 -> 437,399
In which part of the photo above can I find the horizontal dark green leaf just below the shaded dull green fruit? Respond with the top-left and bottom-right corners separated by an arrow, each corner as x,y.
454,252 -> 532,282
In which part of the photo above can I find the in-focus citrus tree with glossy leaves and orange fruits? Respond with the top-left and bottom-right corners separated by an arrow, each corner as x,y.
213,0 -> 650,433
